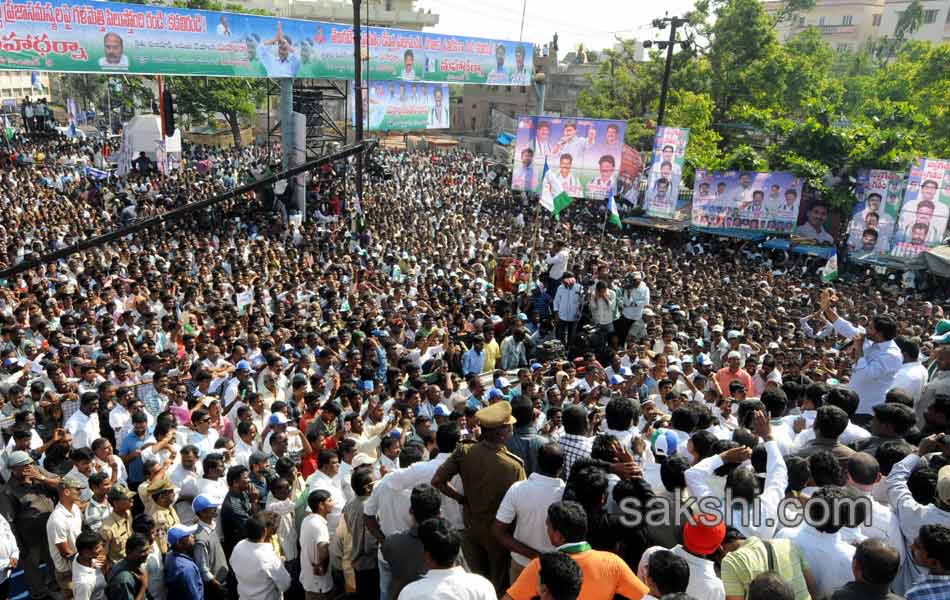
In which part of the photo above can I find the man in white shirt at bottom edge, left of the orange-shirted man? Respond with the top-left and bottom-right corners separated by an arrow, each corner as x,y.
393,518 -> 498,600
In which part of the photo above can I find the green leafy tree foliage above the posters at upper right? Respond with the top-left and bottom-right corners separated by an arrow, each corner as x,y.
578,0 -> 950,214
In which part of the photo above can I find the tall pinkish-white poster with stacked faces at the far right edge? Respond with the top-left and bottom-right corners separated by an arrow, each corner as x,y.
891,158 -> 950,258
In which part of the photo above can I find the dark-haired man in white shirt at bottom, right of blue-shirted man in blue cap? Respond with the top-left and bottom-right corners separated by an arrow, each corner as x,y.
230,516 -> 292,600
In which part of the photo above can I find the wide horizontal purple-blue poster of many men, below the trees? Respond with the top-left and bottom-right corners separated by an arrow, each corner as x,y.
691,171 -> 802,235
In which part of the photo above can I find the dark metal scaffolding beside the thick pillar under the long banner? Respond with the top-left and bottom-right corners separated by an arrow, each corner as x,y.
266,79 -> 348,160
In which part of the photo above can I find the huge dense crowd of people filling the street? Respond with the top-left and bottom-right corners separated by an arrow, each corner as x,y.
0,127 -> 950,600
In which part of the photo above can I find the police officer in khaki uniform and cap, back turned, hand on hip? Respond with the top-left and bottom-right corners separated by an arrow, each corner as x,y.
432,401 -> 525,597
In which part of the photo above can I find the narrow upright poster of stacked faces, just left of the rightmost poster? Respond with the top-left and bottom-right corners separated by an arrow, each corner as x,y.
848,169 -> 904,258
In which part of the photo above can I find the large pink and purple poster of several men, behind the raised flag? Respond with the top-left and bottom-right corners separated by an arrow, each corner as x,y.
511,116 -> 627,200
